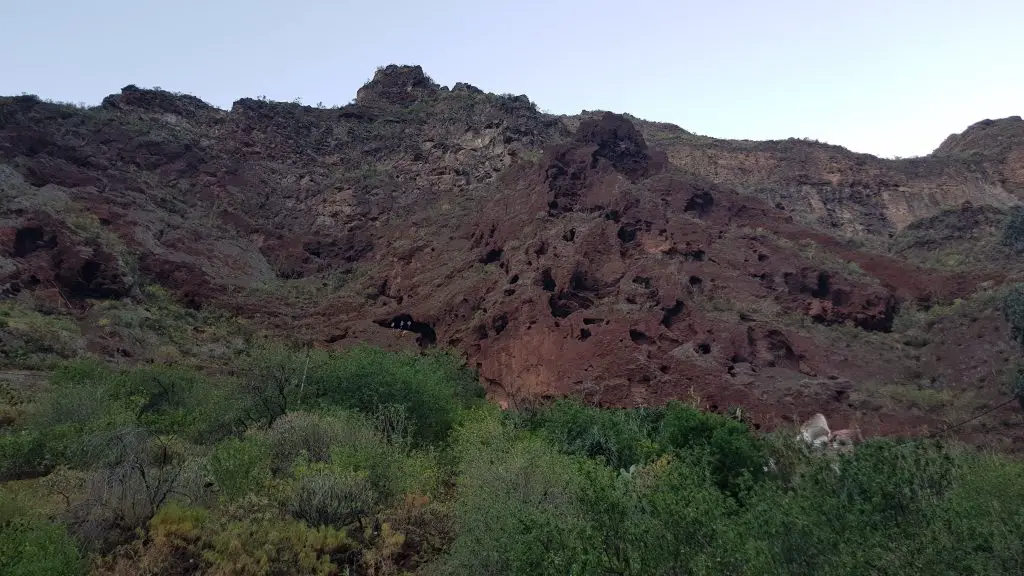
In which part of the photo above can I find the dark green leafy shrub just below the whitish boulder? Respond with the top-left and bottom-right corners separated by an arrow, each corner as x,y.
704,440 -> 961,575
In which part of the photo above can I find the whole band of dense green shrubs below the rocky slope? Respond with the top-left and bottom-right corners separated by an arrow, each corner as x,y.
0,345 -> 1024,575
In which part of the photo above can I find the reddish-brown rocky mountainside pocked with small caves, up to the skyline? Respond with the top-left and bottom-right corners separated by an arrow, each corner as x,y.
6,66 -> 1024,443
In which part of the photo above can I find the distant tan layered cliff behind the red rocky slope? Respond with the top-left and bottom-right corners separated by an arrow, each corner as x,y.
614,117 -> 1024,247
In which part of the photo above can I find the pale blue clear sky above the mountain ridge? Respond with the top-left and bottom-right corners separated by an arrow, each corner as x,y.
0,0 -> 1024,158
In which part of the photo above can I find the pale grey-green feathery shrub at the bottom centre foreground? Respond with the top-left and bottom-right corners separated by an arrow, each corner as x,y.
436,416 -> 600,575
